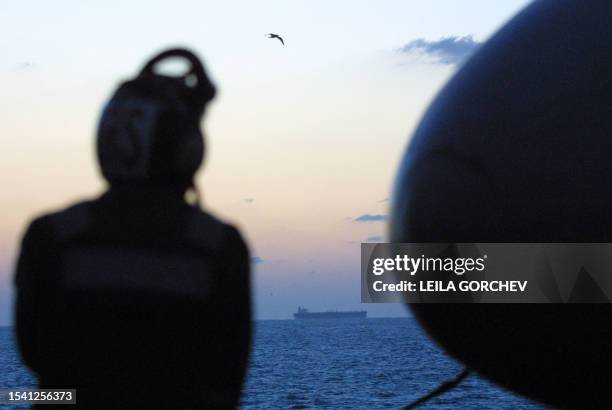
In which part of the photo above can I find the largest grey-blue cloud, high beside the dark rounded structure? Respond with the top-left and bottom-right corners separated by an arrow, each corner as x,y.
399,36 -> 482,64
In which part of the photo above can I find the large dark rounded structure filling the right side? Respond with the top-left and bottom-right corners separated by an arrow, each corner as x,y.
391,0 -> 612,408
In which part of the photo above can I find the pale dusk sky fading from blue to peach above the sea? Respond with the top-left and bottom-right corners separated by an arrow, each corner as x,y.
0,0 -> 528,325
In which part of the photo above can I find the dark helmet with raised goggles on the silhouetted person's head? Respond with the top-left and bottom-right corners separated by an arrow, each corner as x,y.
97,49 -> 215,190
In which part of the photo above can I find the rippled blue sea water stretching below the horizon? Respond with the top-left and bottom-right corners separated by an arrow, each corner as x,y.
0,318 -> 541,409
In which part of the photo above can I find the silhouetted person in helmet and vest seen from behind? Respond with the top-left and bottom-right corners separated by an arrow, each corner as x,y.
16,50 -> 250,409
